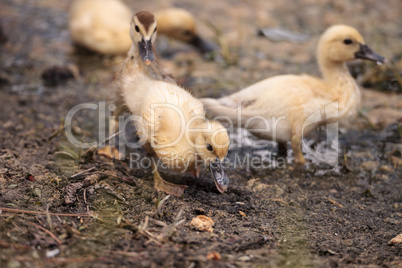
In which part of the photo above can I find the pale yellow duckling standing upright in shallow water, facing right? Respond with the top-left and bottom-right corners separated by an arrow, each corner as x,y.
202,25 -> 385,164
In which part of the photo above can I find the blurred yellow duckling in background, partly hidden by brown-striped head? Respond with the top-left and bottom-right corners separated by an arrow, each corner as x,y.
69,0 -> 213,55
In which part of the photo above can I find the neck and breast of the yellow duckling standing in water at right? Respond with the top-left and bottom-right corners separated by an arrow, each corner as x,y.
320,63 -> 361,117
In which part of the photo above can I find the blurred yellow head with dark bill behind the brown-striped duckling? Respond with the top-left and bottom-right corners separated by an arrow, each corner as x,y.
155,8 -> 214,53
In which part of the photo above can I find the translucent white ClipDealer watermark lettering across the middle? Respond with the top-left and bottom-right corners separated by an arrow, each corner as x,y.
64,101 -> 339,169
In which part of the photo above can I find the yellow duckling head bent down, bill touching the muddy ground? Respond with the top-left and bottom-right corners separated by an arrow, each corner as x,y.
195,120 -> 230,193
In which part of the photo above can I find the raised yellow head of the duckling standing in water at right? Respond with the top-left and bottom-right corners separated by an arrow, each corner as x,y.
317,25 -> 385,68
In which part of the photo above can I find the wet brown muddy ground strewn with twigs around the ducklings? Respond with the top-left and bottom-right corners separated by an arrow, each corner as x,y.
0,0 -> 402,268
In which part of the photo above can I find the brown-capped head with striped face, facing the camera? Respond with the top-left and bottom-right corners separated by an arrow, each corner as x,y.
130,11 -> 156,65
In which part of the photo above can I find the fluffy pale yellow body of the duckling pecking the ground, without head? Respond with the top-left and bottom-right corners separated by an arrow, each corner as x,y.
122,73 -> 205,172
